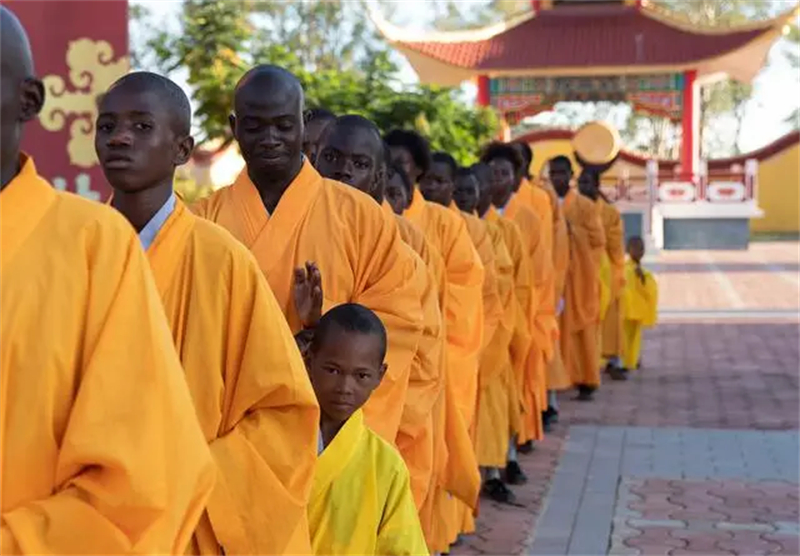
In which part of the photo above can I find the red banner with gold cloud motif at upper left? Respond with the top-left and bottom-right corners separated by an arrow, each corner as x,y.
3,0 -> 129,201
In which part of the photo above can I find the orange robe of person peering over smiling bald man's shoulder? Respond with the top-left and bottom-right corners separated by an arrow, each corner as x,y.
383,202 -> 445,509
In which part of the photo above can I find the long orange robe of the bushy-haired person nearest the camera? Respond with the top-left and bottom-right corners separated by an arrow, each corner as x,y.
404,189 -> 484,552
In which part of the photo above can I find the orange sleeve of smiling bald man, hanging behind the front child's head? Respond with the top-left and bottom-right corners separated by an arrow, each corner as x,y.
351,211 -> 423,442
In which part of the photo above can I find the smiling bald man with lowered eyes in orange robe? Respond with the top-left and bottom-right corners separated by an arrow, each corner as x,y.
193,66 -> 422,443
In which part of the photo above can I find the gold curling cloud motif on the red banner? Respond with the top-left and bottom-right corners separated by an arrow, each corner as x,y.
39,38 -> 129,168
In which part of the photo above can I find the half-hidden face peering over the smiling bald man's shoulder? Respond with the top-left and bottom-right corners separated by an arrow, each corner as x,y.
317,124 -> 383,197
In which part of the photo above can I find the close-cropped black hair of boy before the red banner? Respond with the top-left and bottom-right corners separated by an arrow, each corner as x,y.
104,71 -> 192,135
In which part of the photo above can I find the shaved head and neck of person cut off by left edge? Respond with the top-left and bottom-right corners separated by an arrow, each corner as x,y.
0,6 -> 44,191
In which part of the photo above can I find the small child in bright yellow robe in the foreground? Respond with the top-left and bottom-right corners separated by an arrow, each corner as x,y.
307,303 -> 428,556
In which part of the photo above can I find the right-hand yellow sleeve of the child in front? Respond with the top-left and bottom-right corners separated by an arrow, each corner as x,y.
375,466 -> 429,556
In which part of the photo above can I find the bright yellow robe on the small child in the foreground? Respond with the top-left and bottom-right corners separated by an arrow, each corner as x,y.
308,410 -> 428,556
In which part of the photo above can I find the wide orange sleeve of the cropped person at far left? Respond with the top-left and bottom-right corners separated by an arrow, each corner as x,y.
0,228 -> 215,554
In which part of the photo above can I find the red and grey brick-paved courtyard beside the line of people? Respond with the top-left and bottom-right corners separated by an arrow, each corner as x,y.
452,242 -> 800,555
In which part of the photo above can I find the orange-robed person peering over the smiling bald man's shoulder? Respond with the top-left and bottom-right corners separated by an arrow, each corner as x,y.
317,116 -> 444,520
